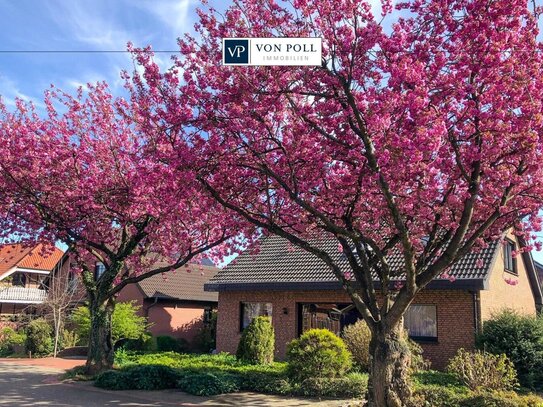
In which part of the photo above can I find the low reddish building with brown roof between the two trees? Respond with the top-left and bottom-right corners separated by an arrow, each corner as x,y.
117,264 -> 219,342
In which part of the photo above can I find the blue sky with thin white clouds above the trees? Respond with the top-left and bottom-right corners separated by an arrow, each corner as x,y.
0,0 -> 543,262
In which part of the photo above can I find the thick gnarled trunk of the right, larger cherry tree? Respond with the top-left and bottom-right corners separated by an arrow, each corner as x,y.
368,324 -> 411,407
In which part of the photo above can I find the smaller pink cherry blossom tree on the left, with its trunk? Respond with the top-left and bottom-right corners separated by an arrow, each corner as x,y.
0,83 -> 251,374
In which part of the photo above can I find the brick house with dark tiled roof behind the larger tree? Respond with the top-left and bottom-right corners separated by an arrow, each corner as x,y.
205,234 -> 542,369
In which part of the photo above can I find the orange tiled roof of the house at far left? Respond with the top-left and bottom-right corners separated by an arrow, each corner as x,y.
0,243 -> 64,278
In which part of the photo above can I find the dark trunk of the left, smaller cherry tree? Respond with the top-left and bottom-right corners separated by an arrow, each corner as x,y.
85,299 -> 115,375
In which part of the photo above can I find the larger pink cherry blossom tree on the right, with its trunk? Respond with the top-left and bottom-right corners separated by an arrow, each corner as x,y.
131,0 -> 543,406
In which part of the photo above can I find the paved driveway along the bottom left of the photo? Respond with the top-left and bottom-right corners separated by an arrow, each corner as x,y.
0,361 -> 356,407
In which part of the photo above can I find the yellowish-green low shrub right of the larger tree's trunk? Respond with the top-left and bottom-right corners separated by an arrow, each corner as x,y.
447,349 -> 518,390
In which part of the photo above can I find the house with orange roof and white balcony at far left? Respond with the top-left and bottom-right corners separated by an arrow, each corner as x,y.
0,244 -> 66,315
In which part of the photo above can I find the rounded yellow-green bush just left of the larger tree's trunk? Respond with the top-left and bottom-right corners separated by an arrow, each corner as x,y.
287,329 -> 351,381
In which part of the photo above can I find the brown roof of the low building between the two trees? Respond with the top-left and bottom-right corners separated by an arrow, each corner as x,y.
137,264 -> 219,302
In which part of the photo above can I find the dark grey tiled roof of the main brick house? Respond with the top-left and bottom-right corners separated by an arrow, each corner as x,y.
205,235 -> 498,291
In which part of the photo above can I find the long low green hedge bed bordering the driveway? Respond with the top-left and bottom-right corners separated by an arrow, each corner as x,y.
95,351 -> 368,398
